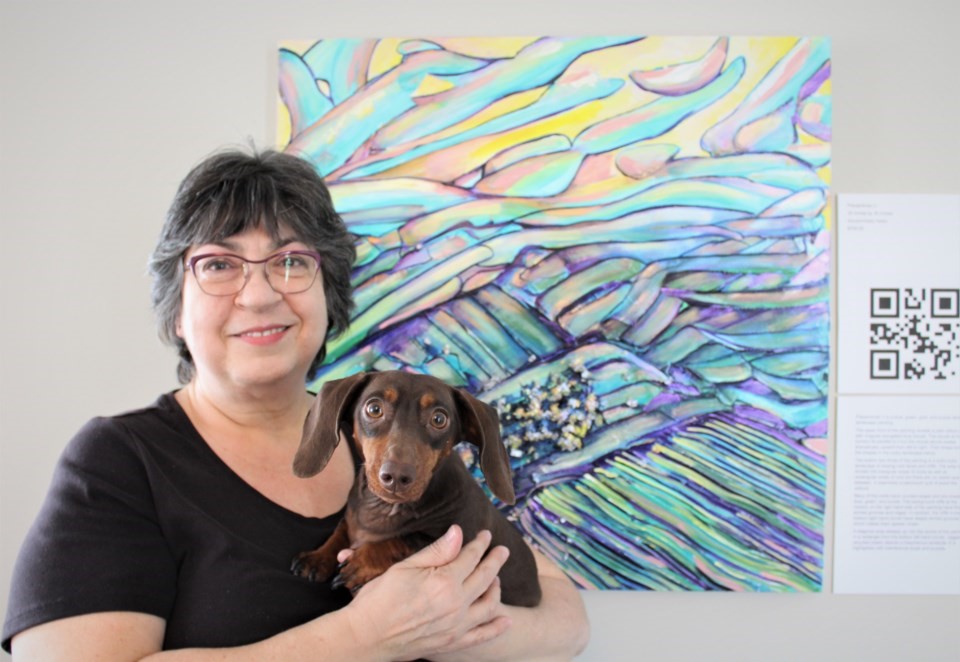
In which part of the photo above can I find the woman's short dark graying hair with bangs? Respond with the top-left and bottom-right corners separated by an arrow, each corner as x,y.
149,150 -> 356,384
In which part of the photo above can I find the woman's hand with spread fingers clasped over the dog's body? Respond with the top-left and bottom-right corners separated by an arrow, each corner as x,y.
341,525 -> 510,659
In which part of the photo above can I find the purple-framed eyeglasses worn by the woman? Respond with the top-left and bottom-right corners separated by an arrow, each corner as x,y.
187,251 -> 320,297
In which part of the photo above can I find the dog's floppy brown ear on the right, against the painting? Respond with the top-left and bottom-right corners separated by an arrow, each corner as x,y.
452,388 -> 517,505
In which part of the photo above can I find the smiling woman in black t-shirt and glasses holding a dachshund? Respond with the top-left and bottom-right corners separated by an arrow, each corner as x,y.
3,151 -> 588,660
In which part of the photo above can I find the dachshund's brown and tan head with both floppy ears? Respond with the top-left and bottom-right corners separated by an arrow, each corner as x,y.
293,371 -> 516,504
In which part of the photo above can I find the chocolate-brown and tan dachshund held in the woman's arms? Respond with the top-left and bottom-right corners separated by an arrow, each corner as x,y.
292,371 -> 540,607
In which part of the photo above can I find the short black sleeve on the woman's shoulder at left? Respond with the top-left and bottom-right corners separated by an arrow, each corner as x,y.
3,418 -> 177,652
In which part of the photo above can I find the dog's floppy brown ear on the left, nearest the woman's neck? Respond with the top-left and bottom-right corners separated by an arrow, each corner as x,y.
293,372 -> 370,478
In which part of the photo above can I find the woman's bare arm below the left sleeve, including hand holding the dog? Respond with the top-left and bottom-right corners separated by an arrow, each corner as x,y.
13,527 -> 509,662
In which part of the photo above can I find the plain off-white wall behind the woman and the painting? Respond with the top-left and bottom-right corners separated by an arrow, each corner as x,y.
0,0 -> 960,660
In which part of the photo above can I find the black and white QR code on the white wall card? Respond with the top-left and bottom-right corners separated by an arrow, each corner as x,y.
870,287 -> 960,381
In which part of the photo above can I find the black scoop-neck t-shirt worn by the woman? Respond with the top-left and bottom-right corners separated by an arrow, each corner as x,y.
3,394 -> 349,652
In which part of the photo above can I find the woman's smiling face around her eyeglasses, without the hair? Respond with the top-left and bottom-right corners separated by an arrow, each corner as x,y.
177,229 -> 327,388
